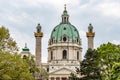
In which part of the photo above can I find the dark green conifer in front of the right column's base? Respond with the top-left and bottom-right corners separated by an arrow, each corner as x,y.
80,49 -> 101,80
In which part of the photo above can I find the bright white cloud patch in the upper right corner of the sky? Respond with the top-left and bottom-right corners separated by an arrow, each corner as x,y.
97,1 -> 120,17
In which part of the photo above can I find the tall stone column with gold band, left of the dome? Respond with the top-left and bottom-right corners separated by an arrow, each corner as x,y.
34,24 -> 43,67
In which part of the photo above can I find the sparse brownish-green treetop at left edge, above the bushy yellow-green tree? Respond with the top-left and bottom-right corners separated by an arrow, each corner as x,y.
0,26 -> 18,53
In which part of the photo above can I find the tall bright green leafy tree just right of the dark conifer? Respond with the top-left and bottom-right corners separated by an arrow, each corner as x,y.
97,42 -> 120,80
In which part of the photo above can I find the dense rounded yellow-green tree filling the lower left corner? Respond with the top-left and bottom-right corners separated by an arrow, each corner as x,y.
0,51 -> 33,80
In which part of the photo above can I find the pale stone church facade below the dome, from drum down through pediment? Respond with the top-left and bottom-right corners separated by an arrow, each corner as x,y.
48,42 -> 82,80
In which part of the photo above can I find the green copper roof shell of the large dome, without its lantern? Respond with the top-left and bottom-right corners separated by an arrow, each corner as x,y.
51,24 -> 80,42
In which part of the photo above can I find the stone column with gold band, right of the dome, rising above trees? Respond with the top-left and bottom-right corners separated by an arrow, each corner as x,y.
86,24 -> 95,49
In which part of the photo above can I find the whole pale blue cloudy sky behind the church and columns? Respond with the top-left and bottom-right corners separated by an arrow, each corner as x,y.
0,0 -> 120,62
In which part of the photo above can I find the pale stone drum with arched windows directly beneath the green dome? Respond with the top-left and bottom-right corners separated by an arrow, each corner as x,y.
48,43 -> 82,62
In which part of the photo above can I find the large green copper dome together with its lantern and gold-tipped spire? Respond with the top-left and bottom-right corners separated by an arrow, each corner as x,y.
49,6 -> 81,45
